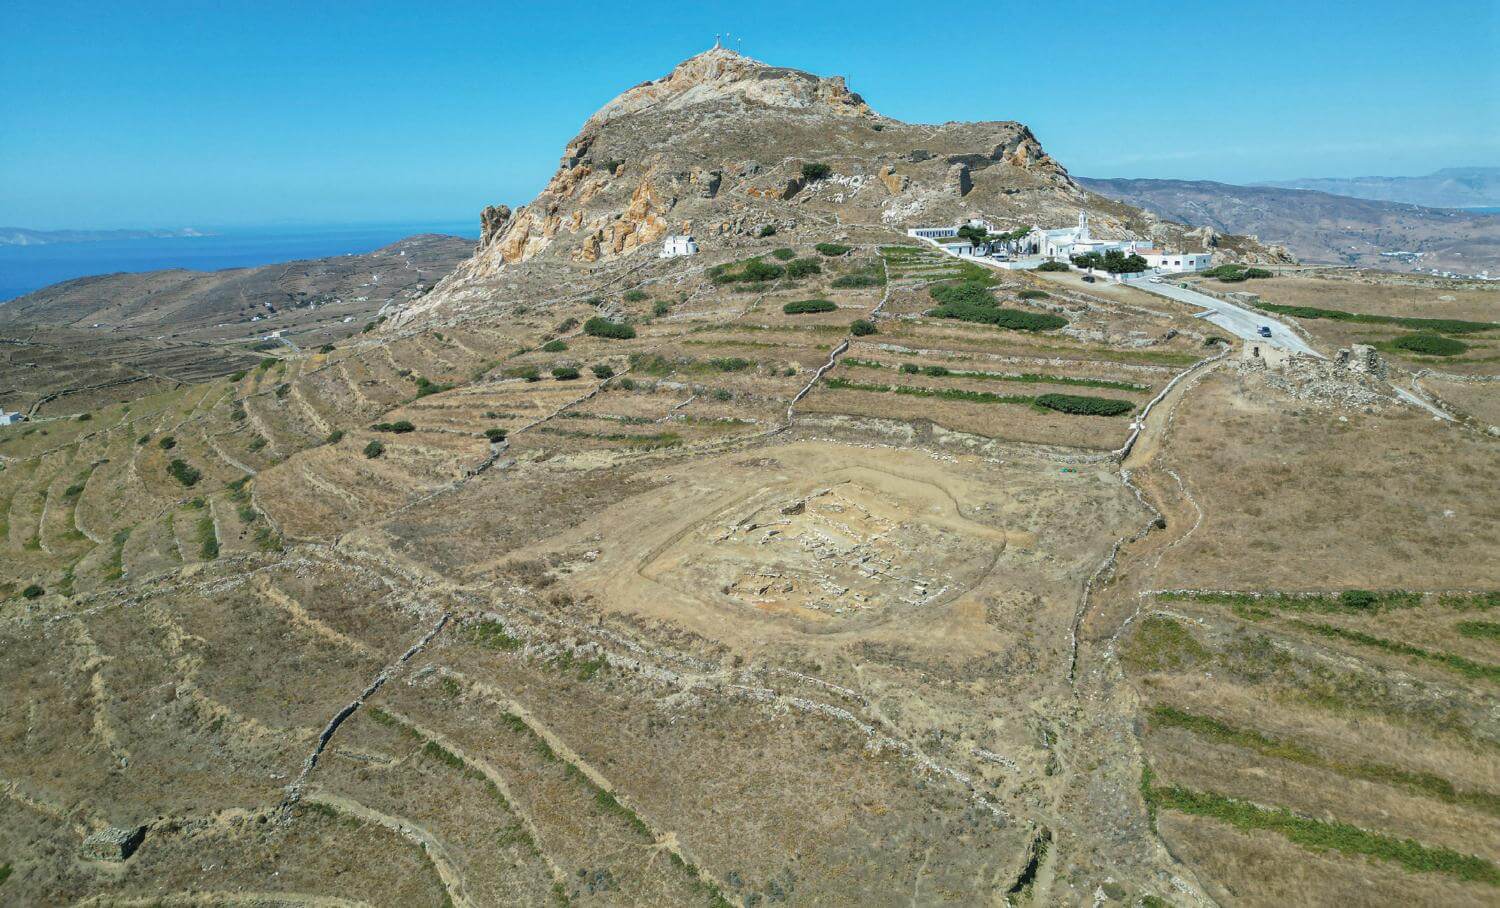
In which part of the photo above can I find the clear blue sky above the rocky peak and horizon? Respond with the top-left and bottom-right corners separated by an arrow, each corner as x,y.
0,0 -> 1500,228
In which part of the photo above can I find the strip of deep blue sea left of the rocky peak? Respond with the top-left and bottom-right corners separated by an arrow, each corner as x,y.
0,221 -> 479,300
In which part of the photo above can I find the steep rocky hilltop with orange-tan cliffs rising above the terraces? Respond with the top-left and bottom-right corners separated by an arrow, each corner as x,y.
411,48 -> 1275,322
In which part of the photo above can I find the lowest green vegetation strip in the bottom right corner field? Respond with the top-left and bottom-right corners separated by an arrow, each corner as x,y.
1142,774 -> 1500,885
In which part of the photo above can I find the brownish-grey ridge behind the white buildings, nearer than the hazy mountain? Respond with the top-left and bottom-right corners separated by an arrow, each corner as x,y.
1074,177 -> 1500,275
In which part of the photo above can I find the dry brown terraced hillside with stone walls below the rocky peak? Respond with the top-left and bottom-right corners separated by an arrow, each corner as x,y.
0,45 -> 1500,906
